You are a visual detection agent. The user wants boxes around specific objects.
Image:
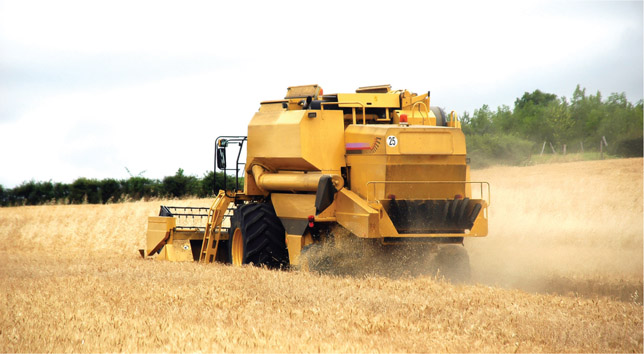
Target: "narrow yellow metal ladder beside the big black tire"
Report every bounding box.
[199,190,234,263]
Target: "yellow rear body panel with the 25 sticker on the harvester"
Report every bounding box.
[345,125,467,199]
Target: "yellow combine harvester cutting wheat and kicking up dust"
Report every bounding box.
[141,85,490,274]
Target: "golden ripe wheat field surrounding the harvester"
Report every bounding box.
[0,159,643,352]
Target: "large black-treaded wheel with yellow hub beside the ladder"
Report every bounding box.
[228,203,289,268]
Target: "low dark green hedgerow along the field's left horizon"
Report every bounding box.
[0,169,243,206]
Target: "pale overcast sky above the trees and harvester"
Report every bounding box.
[0,0,643,188]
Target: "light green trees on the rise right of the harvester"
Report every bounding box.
[461,85,644,167]
